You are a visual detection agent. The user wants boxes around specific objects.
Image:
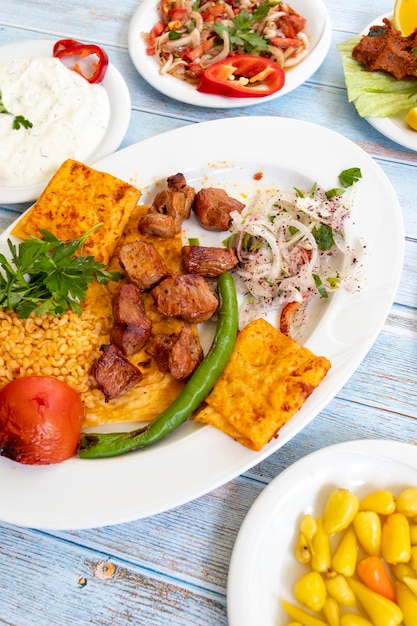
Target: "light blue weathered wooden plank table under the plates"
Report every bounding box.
[0,0,417,626]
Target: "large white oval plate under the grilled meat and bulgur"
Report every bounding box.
[0,116,404,529]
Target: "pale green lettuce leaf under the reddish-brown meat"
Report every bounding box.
[337,36,417,117]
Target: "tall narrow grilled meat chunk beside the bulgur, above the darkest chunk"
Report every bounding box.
[110,283,152,356]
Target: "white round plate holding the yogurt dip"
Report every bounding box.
[0,40,131,204]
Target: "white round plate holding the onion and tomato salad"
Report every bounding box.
[128,0,331,109]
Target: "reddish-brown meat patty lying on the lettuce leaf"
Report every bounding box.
[352,18,417,80]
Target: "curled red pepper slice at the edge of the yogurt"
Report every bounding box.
[53,39,109,83]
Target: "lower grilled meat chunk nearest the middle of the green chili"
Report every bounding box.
[147,323,204,380]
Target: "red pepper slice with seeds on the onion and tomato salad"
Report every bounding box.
[197,54,285,98]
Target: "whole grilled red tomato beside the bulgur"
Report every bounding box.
[0,376,84,465]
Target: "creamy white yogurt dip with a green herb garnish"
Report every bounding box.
[0,57,110,187]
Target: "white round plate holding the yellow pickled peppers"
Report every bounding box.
[227,440,417,626]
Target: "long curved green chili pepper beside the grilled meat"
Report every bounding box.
[78,273,238,459]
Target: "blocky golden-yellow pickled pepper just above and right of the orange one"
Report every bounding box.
[381,512,410,560]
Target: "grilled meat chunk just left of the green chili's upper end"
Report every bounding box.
[151,274,218,324]
